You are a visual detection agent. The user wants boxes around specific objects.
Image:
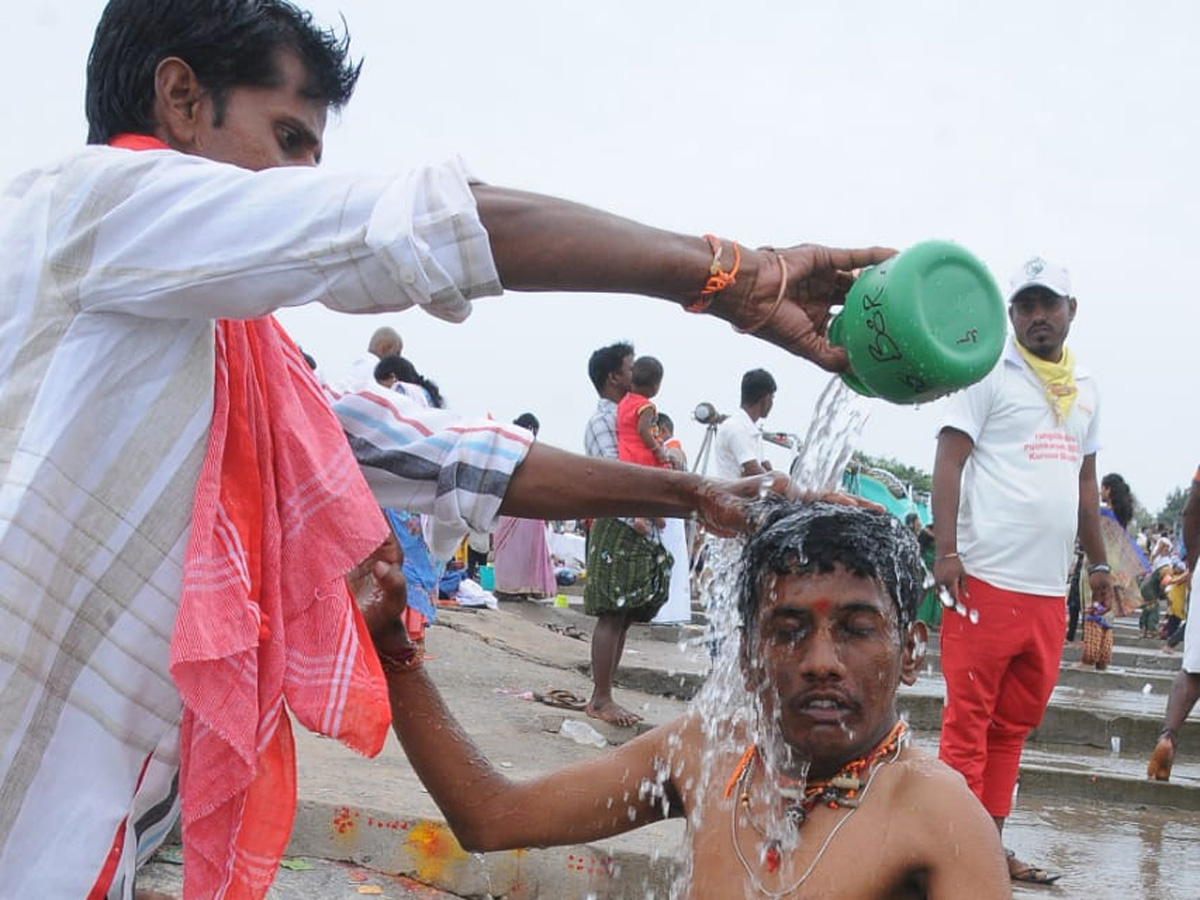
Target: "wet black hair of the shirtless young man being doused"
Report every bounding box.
[738,494,924,630]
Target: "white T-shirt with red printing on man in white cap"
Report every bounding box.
[942,338,1100,596]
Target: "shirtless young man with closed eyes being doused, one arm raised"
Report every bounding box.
[360,499,1012,900]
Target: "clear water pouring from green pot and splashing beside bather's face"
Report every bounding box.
[660,377,869,900]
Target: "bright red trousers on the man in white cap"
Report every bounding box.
[937,577,1067,817]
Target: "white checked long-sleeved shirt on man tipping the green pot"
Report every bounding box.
[0,146,500,896]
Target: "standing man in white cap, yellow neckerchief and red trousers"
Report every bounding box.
[932,257,1111,883]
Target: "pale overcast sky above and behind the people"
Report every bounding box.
[9,0,1200,511]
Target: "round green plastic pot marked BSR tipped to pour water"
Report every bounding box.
[829,241,1008,403]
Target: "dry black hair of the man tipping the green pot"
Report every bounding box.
[85,0,362,144]
